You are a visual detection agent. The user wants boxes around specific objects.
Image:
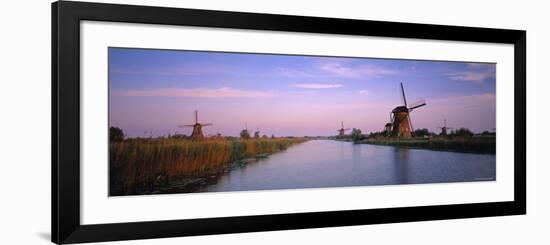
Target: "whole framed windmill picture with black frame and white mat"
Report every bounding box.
[52,1,526,244]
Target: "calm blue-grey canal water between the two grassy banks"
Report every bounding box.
[197,140,496,192]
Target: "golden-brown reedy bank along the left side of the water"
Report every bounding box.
[109,138,304,195]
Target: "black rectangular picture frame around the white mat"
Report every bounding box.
[51,1,526,244]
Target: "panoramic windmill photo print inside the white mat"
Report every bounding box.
[108,47,496,196]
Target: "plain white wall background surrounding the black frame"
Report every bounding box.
[0,0,550,245]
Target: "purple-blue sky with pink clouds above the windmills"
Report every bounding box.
[109,48,496,137]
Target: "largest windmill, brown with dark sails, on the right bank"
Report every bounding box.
[391,83,426,138]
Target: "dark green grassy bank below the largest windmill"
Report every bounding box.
[356,136,496,154]
